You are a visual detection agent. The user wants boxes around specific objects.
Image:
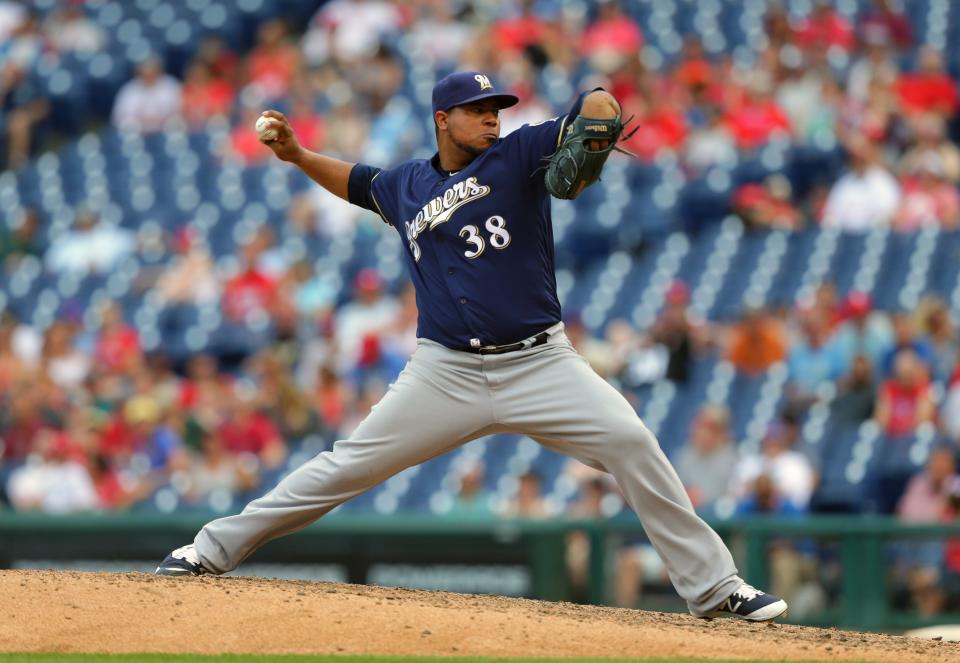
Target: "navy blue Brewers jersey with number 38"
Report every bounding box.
[349,95,584,350]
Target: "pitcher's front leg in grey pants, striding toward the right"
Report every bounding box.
[495,343,742,614]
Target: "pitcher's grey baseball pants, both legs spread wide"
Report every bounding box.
[194,325,742,615]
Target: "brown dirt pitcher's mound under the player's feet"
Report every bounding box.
[0,571,960,663]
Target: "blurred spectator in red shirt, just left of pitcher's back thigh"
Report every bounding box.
[217,384,287,469]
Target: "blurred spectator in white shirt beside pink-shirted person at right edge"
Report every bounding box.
[823,134,900,232]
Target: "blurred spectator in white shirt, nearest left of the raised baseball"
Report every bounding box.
[113,58,181,133]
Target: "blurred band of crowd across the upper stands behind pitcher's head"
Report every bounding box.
[0,0,960,231]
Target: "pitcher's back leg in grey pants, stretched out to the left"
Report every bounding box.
[194,350,491,573]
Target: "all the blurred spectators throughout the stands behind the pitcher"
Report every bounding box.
[0,0,960,611]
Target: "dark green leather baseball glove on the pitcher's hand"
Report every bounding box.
[544,116,633,200]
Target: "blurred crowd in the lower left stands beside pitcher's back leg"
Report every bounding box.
[0,258,416,512]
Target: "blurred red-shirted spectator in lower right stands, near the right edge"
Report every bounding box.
[874,349,936,437]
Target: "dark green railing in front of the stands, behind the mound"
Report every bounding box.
[0,512,960,631]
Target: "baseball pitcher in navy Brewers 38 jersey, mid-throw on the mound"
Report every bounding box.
[157,72,787,621]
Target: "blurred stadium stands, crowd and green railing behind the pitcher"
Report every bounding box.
[0,0,960,629]
